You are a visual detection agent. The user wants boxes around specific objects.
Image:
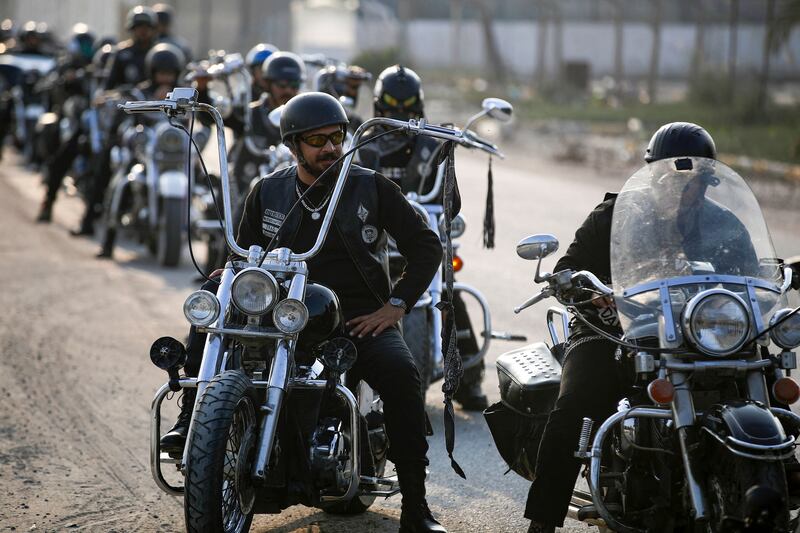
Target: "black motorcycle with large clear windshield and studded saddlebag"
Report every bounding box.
[486,158,800,532]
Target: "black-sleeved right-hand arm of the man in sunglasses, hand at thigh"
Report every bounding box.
[375,174,442,310]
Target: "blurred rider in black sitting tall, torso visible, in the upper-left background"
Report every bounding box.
[105,6,158,89]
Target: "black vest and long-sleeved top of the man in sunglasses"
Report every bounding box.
[236,165,442,310]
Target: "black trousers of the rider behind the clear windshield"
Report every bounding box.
[525,336,625,527]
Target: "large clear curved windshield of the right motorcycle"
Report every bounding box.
[611,158,785,345]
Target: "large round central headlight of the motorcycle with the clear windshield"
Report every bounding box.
[683,289,750,357]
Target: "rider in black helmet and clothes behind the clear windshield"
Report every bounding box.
[525,122,717,533]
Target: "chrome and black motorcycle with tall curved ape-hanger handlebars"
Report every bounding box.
[122,88,476,532]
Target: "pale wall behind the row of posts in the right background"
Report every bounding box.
[357,19,800,79]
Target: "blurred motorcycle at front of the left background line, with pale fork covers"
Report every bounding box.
[103,89,208,267]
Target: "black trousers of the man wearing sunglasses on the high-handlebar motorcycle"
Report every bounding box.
[184,282,428,469]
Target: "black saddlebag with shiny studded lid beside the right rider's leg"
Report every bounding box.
[483,343,561,480]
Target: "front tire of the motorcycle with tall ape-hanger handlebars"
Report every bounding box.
[184,370,258,533]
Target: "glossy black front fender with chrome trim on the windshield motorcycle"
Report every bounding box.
[700,401,794,460]
